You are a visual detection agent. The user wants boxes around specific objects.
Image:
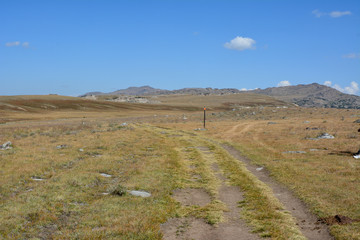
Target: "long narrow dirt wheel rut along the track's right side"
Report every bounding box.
[222,145,334,240]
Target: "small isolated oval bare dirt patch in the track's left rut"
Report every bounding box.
[173,188,211,207]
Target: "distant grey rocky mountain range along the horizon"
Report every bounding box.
[81,83,360,109]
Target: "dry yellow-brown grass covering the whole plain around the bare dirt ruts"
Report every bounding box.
[0,96,360,239]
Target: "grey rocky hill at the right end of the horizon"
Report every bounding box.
[250,83,360,109]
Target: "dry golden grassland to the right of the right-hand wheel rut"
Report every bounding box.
[161,107,360,239]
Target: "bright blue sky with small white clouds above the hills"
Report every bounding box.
[0,0,360,96]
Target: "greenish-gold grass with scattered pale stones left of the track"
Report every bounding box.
[0,125,186,239]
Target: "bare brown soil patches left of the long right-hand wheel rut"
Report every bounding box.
[161,147,260,240]
